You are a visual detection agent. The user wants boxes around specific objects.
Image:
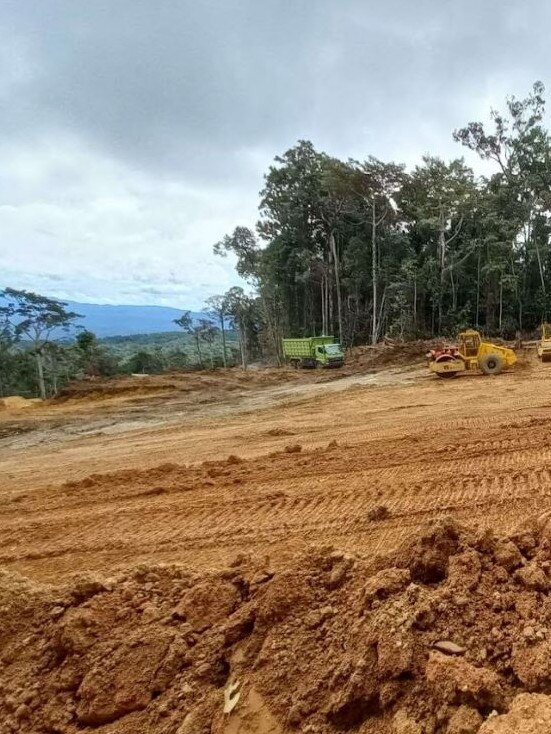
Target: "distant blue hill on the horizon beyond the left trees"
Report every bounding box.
[66,301,205,337]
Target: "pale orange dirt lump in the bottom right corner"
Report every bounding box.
[478,693,551,734]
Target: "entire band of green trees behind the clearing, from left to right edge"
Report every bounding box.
[0,82,551,397]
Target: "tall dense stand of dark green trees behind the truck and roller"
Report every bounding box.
[209,82,551,364]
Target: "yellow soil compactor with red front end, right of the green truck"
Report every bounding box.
[427,329,516,377]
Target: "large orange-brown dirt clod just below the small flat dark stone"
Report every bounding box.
[426,652,504,710]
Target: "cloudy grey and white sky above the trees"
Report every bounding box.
[0,0,551,309]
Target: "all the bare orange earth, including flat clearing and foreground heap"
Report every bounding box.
[5,344,551,734]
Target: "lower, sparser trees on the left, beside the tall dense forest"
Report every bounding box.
[0,288,241,399]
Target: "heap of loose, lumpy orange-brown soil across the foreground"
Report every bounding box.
[5,516,551,734]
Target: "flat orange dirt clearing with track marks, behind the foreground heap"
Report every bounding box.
[0,364,551,579]
